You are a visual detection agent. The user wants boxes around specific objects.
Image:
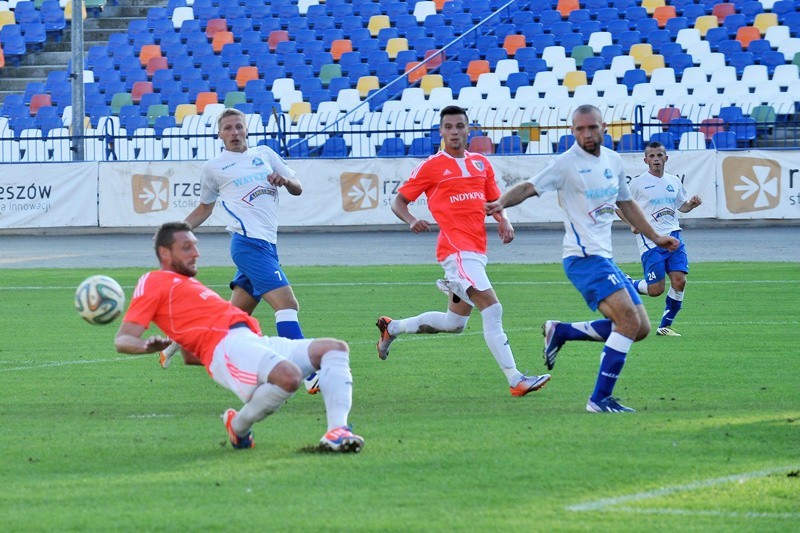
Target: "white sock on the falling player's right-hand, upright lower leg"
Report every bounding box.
[319,350,353,431]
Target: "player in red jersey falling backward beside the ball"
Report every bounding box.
[114,222,364,452]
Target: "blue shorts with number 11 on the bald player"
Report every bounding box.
[562,255,642,311]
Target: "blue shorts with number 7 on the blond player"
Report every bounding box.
[231,233,289,300]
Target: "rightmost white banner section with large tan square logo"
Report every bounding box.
[715,150,800,219]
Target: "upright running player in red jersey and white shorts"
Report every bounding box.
[377,106,550,396]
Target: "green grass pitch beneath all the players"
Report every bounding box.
[0,263,800,532]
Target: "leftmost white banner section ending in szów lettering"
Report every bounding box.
[0,162,97,229]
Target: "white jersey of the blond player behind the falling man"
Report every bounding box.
[200,146,294,244]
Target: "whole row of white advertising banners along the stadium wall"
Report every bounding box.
[0,150,800,229]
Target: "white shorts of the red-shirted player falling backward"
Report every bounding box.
[208,328,314,403]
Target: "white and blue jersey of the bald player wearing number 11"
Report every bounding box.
[528,143,630,258]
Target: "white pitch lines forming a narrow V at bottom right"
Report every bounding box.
[566,465,800,518]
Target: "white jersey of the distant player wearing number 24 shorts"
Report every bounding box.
[630,172,688,254]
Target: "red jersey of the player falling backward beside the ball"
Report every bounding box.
[123,270,261,368]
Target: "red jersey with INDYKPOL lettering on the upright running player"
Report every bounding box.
[399,151,500,261]
